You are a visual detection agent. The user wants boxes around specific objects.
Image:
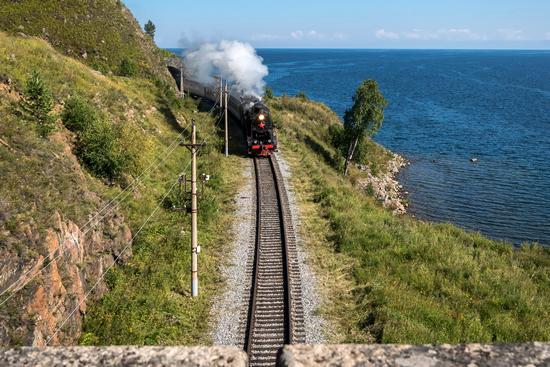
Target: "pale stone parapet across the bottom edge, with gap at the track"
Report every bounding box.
[0,343,550,367]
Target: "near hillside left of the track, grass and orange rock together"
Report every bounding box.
[0,25,244,345]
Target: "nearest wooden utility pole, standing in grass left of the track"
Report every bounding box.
[184,119,203,297]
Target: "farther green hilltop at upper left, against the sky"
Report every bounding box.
[0,0,168,79]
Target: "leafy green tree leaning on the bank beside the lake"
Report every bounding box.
[344,80,388,175]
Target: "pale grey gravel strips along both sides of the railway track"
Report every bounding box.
[211,154,326,346]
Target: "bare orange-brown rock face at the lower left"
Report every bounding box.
[0,212,132,346]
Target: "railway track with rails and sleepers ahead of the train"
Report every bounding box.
[244,156,305,366]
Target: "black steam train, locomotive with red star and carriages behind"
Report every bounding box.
[183,79,277,156]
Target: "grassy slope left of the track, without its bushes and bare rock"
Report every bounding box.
[0,32,244,345]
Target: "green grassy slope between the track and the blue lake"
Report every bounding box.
[270,97,550,343]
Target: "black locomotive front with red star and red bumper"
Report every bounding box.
[248,102,277,156]
